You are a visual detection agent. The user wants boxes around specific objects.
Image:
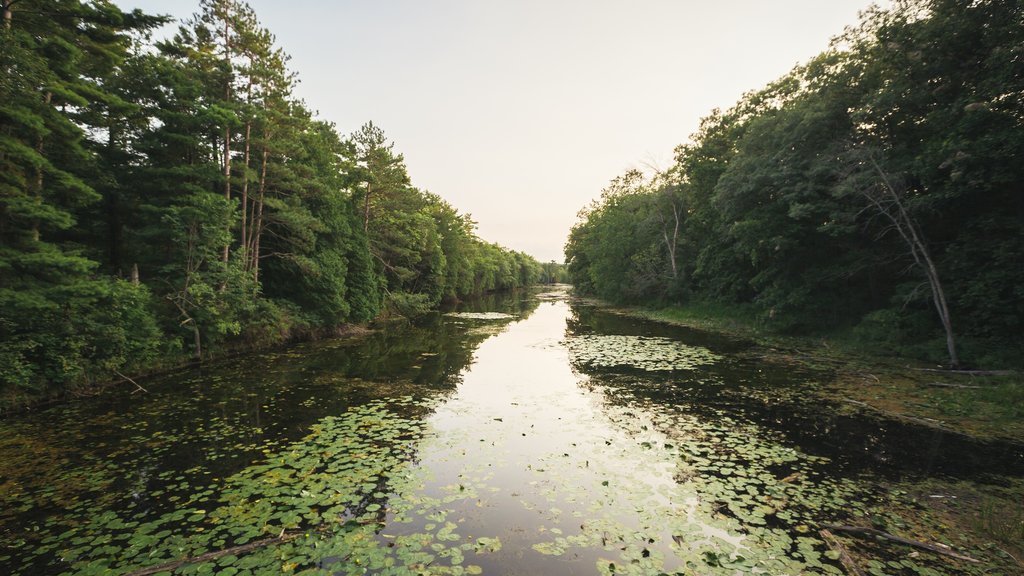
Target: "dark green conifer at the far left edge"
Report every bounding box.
[0,0,159,388]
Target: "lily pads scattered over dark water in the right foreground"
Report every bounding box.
[588,378,990,576]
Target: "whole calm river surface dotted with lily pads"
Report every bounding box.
[0,290,1024,575]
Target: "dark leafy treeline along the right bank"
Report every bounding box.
[565,0,1024,365]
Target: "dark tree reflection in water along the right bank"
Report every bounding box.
[566,305,1024,478]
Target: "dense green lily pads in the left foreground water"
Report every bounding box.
[2,398,501,574]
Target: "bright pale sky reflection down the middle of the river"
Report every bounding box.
[364,293,795,574]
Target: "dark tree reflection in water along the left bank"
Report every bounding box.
[0,294,538,574]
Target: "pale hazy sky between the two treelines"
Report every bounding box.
[110,0,870,261]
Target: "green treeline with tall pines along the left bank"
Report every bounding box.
[0,0,543,397]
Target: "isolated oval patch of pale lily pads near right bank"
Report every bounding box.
[564,334,722,372]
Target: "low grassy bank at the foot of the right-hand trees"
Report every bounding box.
[588,300,1024,443]
